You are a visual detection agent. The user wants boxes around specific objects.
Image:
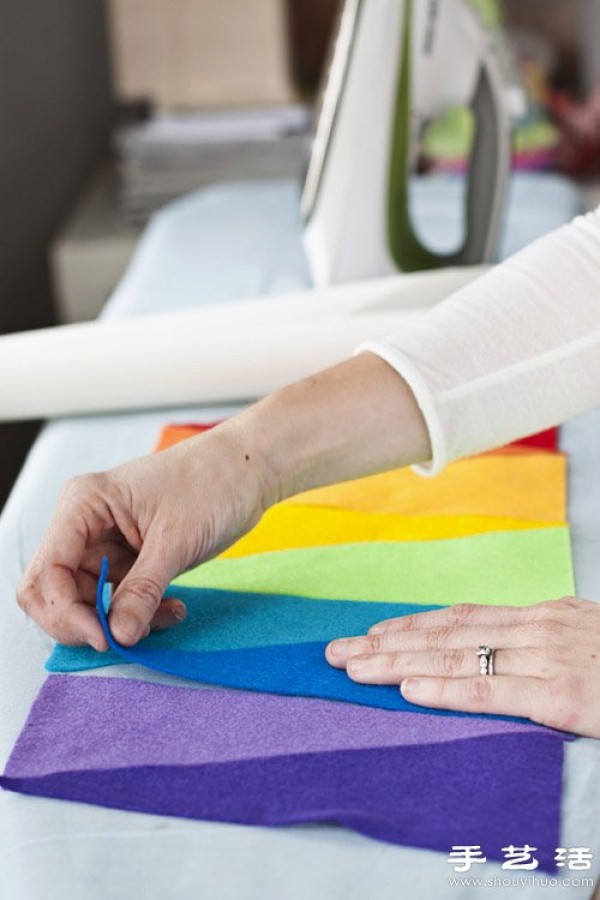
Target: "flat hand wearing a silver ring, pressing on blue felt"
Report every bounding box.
[327,597,600,738]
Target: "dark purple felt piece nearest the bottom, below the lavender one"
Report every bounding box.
[0,732,563,870]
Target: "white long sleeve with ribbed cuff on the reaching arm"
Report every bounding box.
[358,207,600,475]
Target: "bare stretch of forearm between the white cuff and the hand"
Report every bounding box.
[228,353,431,506]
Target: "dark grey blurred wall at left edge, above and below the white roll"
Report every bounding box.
[0,0,112,507]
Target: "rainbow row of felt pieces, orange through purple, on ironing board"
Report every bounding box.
[7,426,573,870]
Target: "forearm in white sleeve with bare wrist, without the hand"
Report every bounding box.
[203,212,600,506]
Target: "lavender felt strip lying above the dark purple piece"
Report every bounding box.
[0,675,563,777]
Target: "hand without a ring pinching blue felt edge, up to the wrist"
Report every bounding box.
[17,420,268,650]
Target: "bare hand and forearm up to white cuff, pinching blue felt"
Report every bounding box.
[17,353,431,650]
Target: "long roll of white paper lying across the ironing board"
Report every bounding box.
[0,267,484,421]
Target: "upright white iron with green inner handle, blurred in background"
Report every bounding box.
[302,0,511,286]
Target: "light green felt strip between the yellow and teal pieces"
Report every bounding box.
[175,526,575,606]
